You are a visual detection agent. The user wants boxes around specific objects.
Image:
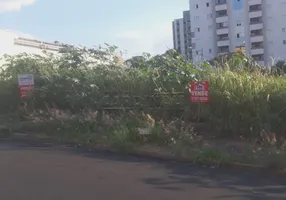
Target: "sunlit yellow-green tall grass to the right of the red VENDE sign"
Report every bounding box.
[208,70,286,138]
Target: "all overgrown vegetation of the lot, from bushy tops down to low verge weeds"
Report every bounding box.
[0,46,286,172]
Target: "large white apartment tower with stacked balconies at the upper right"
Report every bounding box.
[173,0,286,65]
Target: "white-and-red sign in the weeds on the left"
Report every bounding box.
[18,74,35,99]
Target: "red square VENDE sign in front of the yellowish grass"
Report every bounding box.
[191,81,209,103]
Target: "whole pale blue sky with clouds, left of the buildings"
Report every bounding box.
[0,0,188,56]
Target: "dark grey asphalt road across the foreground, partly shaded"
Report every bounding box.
[0,142,286,200]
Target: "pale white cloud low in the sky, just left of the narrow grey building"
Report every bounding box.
[115,23,173,57]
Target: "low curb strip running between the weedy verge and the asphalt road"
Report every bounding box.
[0,133,286,178]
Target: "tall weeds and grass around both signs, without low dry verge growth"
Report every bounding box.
[0,49,286,140]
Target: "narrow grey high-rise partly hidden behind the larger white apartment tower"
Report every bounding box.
[173,11,192,59]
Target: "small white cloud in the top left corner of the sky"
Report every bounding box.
[0,0,36,13]
